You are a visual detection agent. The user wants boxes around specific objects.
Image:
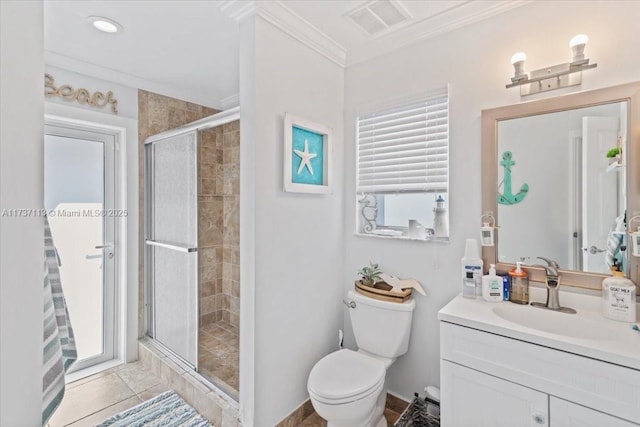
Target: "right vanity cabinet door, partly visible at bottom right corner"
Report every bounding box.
[549,396,639,427]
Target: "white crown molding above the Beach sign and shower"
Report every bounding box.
[44,50,222,110]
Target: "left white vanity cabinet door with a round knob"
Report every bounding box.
[440,360,549,427]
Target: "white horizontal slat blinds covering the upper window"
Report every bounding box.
[356,90,449,193]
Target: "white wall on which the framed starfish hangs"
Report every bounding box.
[240,18,344,427]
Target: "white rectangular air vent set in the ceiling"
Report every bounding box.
[346,0,411,36]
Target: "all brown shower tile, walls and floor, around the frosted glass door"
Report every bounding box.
[138,90,240,399]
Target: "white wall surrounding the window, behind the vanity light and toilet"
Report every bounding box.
[342,1,640,399]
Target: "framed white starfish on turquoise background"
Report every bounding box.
[284,113,331,194]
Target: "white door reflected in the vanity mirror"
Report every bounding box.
[582,117,619,273]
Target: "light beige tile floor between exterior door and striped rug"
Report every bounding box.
[49,362,169,427]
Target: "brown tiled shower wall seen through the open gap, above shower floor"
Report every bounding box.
[198,121,240,327]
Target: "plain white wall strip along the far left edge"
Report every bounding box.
[0,1,44,427]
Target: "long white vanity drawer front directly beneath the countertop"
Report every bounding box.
[440,322,640,423]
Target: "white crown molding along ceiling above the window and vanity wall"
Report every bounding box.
[346,0,533,66]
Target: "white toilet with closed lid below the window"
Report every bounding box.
[307,291,416,427]
